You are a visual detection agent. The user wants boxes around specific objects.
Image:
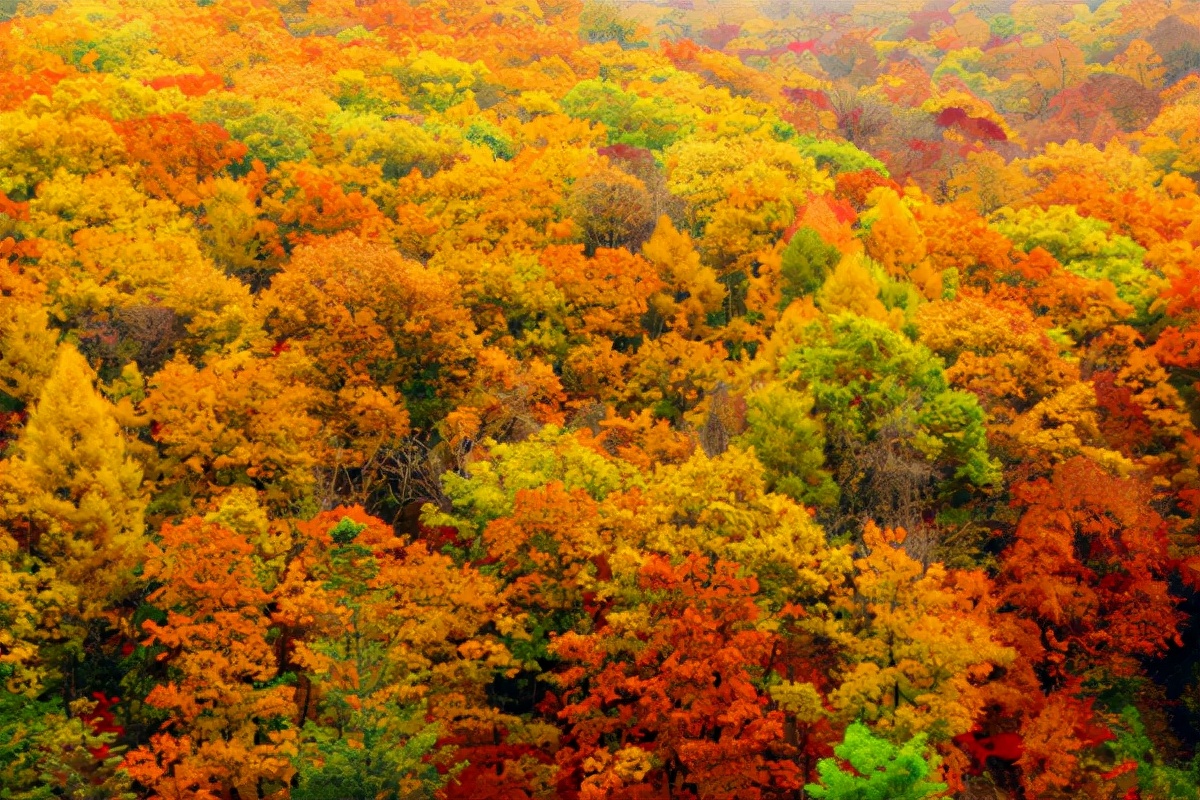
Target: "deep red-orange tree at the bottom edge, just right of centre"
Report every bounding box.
[552,555,803,798]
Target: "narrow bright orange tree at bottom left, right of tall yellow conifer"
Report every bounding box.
[124,517,296,800]
